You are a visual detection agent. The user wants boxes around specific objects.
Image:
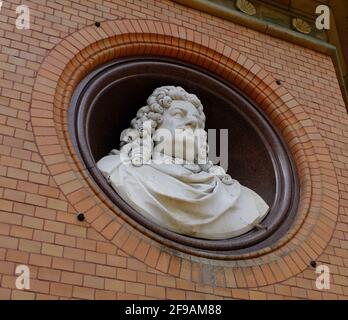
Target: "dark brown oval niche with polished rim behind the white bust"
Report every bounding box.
[69,57,299,256]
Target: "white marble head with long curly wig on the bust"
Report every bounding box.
[121,86,205,164]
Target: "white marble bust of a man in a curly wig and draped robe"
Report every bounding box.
[97,86,269,239]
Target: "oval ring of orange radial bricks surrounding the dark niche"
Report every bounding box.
[31,20,338,288]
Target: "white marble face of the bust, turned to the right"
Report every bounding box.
[153,100,205,161]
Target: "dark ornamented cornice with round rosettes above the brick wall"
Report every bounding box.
[173,0,348,110]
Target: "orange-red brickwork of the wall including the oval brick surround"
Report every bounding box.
[0,1,348,299]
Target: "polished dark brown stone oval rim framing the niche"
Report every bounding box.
[68,57,300,257]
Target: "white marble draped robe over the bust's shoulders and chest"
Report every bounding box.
[97,154,269,239]
